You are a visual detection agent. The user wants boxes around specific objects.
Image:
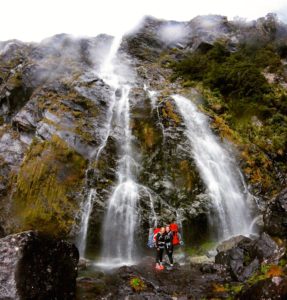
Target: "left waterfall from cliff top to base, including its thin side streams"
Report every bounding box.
[78,38,162,267]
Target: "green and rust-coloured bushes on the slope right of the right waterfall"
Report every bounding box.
[172,42,287,192]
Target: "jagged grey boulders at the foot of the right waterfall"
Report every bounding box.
[215,233,285,281]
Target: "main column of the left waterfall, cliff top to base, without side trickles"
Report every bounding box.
[95,38,144,266]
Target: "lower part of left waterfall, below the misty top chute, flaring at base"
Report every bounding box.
[102,84,139,265]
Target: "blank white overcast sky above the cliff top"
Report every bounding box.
[0,0,287,42]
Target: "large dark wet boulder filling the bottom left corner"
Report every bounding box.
[0,231,79,300]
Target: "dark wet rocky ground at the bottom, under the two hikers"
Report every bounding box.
[77,233,287,300]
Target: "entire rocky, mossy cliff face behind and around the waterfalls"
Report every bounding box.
[0,15,287,248]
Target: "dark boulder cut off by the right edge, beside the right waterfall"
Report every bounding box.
[264,189,287,238]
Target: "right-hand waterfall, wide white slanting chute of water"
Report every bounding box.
[173,95,251,240]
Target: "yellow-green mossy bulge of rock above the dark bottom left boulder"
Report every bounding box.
[13,136,86,236]
